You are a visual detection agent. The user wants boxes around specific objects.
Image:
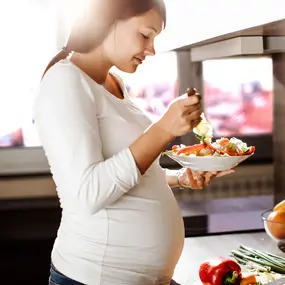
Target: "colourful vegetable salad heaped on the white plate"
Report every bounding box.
[168,113,255,156]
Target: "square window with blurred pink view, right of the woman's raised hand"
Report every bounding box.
[203,57,273,137]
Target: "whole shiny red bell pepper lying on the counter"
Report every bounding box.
[199,257,242,285]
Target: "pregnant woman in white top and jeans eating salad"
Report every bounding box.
[34,0,232,285]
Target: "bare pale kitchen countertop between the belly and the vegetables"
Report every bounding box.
[174,232,285,285]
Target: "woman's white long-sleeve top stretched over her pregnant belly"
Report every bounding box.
[34,60,184,285]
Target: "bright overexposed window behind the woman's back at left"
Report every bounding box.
[0,0,57,147]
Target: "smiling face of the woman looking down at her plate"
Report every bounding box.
[103,9,163,73]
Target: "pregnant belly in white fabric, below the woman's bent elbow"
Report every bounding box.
[57,165,184,285]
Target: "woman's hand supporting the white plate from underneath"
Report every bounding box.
[177,168,235,189]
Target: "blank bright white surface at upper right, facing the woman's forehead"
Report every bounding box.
[156,0,285,51]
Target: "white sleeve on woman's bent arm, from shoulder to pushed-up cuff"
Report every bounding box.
[34,64,141,215]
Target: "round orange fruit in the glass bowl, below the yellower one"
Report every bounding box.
[267,210,285,239]
